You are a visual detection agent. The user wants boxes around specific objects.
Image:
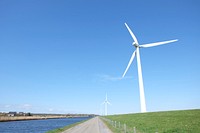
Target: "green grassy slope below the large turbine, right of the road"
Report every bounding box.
[105,109,200,133]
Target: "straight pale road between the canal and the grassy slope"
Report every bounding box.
[63,117,112,133]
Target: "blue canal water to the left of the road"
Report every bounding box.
[0,117,89,133]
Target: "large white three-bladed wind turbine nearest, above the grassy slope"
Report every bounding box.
[122,23,178,113]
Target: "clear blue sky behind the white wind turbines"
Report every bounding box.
[0,0,200,114]
